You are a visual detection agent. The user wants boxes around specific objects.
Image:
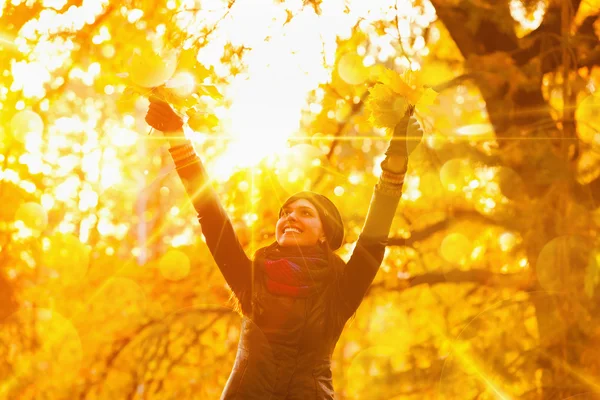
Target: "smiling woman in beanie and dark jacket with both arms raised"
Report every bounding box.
[146,99,422,400]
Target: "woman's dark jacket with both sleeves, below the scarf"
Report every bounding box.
[169,145,399,400]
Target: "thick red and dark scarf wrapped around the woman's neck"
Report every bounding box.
[255,243,334,298]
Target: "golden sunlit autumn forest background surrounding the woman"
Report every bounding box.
[0,0,600,400]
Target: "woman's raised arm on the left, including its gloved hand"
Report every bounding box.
[146,99,252,300]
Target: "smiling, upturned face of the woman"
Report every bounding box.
[275,199,325,247]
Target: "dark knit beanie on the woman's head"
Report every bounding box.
[279,191,344,250]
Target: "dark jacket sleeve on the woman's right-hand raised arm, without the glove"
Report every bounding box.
[338,173,404,315]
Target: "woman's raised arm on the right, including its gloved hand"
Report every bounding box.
[339,110,422,314]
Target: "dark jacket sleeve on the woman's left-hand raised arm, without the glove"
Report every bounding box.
[169,142,252,298]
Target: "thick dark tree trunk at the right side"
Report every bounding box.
[432,0,600,399]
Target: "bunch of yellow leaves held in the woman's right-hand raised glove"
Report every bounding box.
[366,68,437,129]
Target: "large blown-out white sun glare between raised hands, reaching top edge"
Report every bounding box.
[177,0,432,175]
